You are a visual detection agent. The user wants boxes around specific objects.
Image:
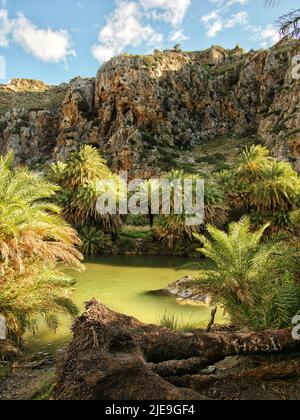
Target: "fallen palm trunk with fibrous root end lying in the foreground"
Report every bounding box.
[53,301,300,400]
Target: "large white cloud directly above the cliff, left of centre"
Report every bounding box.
[92,0,163,62]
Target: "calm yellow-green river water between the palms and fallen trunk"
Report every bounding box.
[26,256,221,353]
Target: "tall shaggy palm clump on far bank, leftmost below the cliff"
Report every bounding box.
[46,146,122,255]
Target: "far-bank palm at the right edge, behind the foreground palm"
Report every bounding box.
[218,146,300,230]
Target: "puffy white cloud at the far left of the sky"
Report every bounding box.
[0,9,76,63]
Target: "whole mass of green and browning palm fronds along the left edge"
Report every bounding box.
[0,153,83,344]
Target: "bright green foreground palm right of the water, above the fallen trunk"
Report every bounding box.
[195,217,300,328]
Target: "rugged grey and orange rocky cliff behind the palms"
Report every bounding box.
[0,40,300,174]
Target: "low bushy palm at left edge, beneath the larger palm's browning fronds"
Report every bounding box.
[0,259,78,346]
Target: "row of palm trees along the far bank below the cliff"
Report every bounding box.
[47,146,300,253]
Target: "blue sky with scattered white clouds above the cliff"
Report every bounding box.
[0,0,299,84]
